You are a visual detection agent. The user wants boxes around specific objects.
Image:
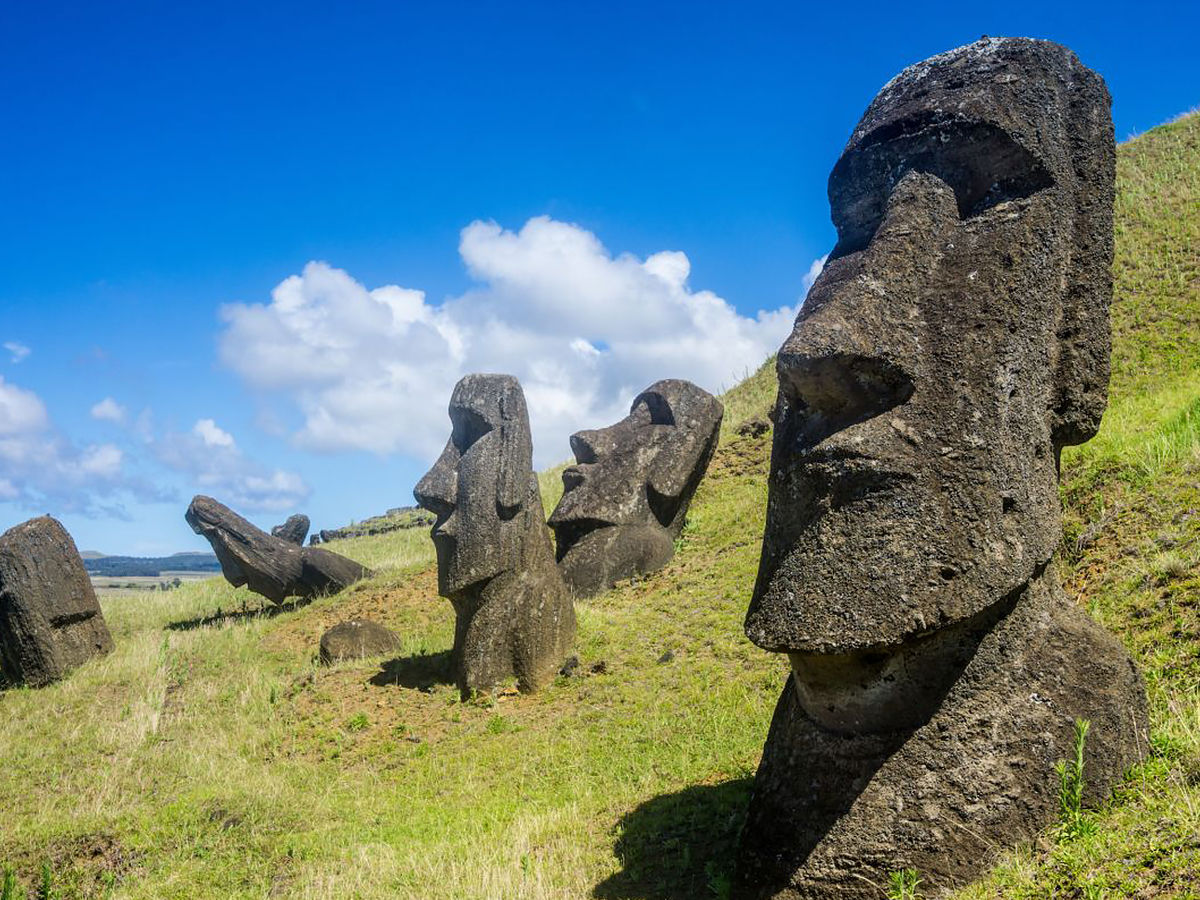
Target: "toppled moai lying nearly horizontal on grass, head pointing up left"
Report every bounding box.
[185,494,371,604]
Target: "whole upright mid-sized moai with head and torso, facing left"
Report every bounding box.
[413,374,575,696]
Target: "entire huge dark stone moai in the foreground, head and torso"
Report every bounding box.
[734,38,1147,898]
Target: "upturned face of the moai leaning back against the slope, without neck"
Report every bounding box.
[550,379,722,540]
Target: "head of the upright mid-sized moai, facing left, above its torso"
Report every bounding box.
[413,374,541,598]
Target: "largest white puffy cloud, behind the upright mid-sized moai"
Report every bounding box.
[220,216,796,464]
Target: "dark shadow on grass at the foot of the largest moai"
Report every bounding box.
[593,776,754,900]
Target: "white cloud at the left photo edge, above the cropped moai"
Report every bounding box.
[0,378,128,514]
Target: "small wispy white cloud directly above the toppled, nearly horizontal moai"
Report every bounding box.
[150,419,311,512]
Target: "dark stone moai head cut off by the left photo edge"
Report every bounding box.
[0,516,113,685]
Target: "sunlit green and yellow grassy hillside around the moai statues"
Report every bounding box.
[0,116,1200,900]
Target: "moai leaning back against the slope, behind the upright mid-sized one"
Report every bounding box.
[550,379,725,596]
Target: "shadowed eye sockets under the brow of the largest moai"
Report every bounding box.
[829,113,1054,258]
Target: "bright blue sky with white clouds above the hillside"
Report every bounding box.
[0,2,1200,554]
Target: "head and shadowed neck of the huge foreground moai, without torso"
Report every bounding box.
[745,38,1115,731]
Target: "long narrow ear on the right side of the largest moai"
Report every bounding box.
[1050,60,1116,449]
